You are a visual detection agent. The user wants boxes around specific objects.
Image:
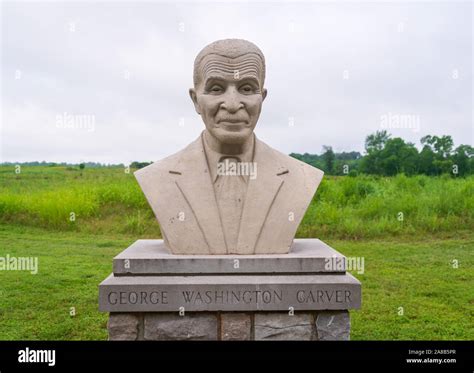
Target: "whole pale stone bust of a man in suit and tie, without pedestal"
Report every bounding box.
[135,39,323,254]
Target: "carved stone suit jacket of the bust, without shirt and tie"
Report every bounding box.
[135,135,324,254]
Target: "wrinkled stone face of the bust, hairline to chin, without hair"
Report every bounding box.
[189,54,267,144]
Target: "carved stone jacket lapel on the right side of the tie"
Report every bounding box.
[237,138,288,254]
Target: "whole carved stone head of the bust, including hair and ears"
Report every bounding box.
[189,39,267,151]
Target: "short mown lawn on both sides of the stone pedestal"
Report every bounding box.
[0,225,474,340]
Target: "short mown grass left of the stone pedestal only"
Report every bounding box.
[0,225,133,340]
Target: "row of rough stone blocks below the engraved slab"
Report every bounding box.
[107,310,350,341]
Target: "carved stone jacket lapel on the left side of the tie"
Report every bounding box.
[170,136,227,254]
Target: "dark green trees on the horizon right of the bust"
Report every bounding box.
[290,130,474,176]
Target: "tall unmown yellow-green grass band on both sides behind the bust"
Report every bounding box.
[0,166,474,239]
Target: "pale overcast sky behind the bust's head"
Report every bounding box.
[0,2,473,163]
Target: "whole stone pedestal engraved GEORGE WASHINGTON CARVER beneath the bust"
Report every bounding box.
[99,239,361,340]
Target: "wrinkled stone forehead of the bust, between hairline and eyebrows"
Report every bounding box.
[197,52,265,83]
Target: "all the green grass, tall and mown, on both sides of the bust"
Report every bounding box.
[0,166,474,340]
